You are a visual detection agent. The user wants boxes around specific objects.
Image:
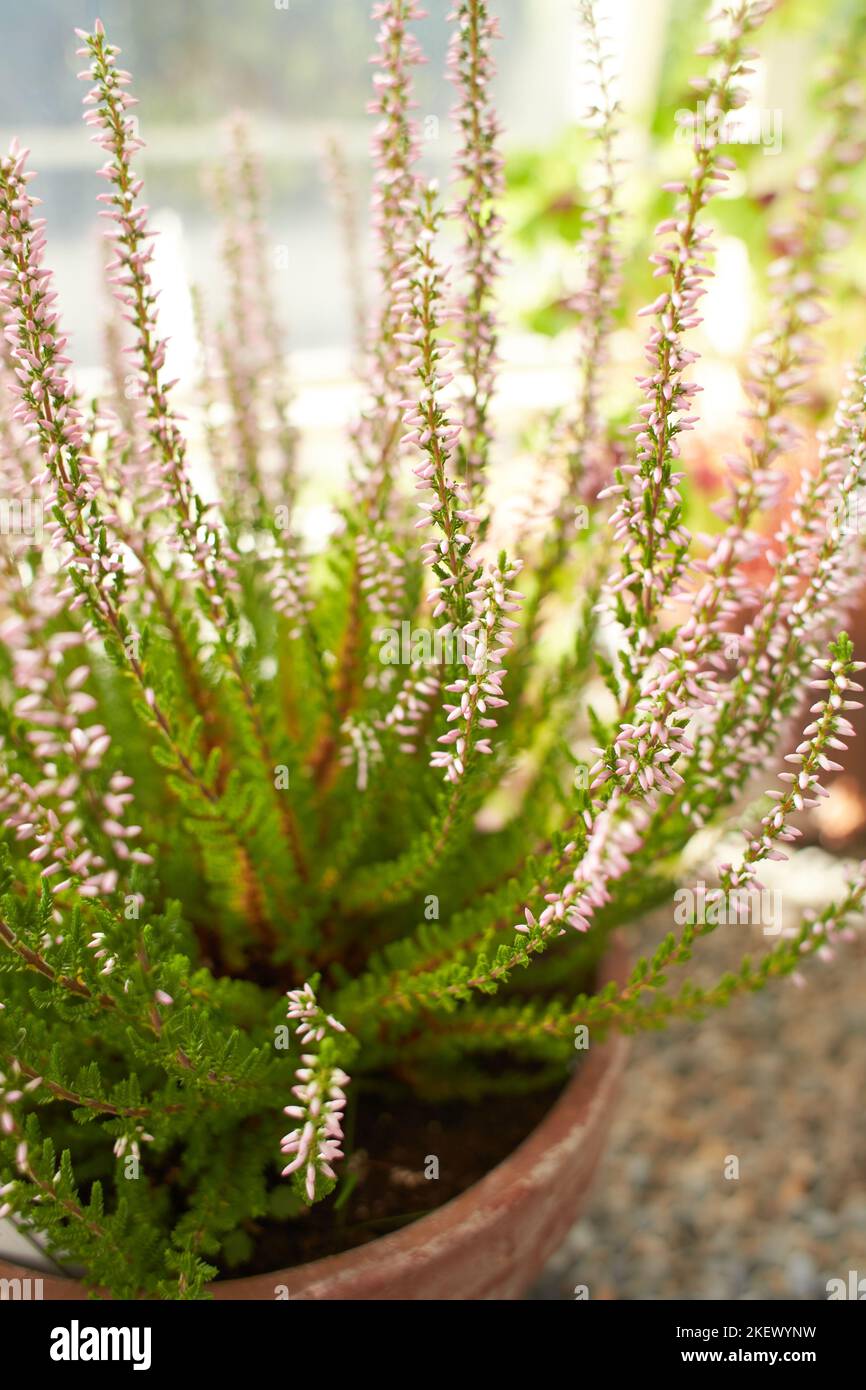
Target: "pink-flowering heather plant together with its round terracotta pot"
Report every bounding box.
[0,0,866,1298]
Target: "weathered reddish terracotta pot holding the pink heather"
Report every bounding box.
[0,945,628,1301]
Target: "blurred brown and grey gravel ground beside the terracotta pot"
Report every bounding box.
[528,851,866,1300]
